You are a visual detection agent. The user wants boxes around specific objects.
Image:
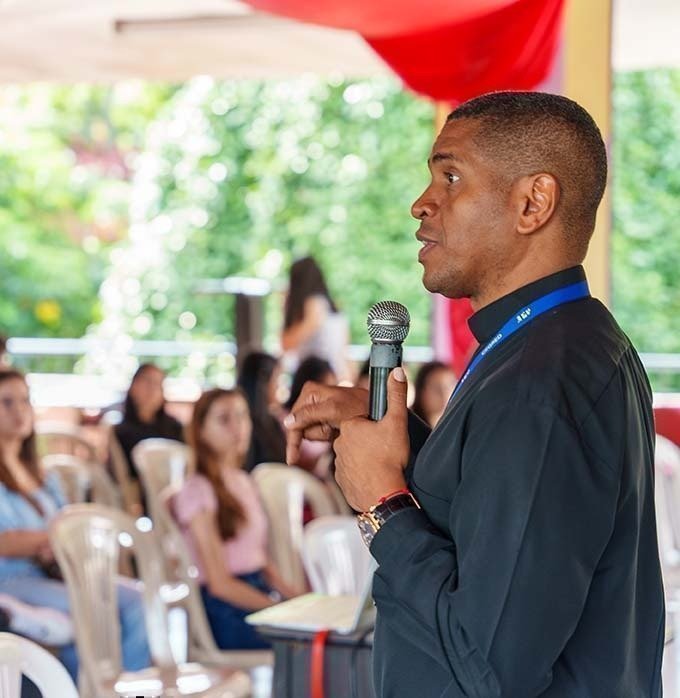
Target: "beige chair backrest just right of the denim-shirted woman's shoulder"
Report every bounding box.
[42,453,122,509]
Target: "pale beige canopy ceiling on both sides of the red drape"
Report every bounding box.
[0,0,680,83]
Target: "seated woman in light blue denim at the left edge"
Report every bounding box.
[0,370,151,679]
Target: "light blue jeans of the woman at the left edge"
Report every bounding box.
[0,577,151,681]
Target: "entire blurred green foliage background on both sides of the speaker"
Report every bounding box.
[0,70,680,386]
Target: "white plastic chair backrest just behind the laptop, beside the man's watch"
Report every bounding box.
[302,516,371,596]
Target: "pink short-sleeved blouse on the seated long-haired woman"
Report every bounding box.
[174,470,267,583]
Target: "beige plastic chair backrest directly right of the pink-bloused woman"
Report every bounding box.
[251,463,337,589]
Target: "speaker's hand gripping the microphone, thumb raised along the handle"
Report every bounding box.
[333,368,410,511]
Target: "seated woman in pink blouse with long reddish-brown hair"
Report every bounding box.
[174,388,295,650]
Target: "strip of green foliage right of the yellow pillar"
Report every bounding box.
[612,70,680,389]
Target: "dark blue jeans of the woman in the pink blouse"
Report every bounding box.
[201,572,271,650]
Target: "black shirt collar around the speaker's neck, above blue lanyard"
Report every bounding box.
[468,266,586,344]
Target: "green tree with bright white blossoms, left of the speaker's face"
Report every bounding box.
[98,77,433,380]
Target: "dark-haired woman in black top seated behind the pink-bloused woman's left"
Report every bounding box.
[114,364,184,480]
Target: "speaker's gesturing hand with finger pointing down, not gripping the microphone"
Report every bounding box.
[283,381,368,465]
